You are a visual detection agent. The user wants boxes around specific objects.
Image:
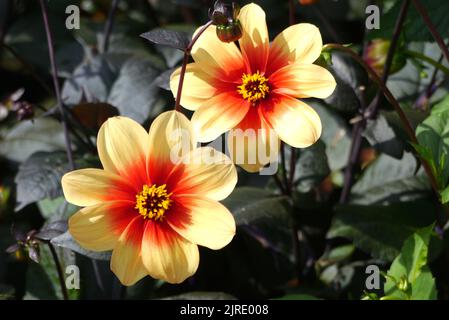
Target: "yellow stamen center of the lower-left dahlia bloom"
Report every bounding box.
[134,184,173,221]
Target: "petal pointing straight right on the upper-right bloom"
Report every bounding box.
[270,64,336,99]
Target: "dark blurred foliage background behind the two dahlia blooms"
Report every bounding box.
[0,0,449,299]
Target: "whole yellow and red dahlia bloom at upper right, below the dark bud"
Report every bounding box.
[170,4,336,171]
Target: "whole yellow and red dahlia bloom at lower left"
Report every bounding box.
[62,111,237,285]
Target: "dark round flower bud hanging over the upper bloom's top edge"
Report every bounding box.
[209,0,242,42]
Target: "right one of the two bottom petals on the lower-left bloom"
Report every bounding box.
[142,221,199,283]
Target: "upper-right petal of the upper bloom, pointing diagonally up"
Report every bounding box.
[267,23,323,75]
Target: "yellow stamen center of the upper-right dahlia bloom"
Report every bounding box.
[237,71,270,103]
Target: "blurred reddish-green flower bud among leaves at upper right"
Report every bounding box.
[363,39,406,77]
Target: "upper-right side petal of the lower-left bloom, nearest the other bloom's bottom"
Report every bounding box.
[169,147,237,200]
